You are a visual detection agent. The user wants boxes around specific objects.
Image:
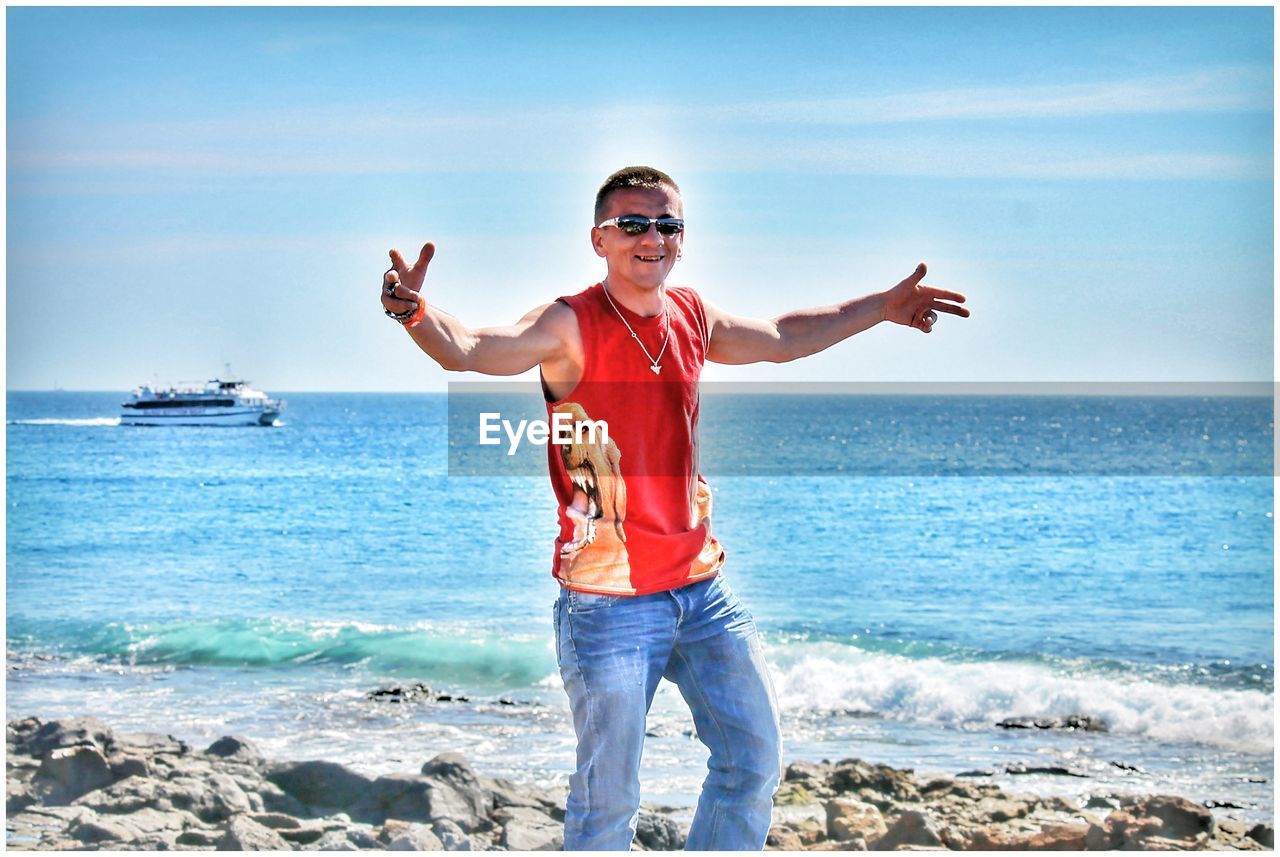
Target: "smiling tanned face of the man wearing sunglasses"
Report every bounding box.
[591,188,685,292]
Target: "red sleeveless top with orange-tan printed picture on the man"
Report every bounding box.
[547,283,724,595]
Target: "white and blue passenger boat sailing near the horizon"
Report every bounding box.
[120,379,284,426]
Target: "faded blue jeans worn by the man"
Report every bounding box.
[556,574,782,851]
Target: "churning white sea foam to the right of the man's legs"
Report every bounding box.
[769,643,1275,753]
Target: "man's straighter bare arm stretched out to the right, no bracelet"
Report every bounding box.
[705,262,969,363]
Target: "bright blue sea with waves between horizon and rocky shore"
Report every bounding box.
[5,386,1275,822]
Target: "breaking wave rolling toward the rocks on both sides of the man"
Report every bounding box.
[9,618,1275,752]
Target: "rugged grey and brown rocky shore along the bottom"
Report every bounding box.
[6,718,1272,851]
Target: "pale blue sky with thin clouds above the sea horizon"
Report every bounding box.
[6,6,1274,391]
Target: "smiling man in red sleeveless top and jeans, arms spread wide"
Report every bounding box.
[383,166,969,851]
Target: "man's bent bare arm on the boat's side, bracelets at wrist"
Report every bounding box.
[383,243,572,375]
